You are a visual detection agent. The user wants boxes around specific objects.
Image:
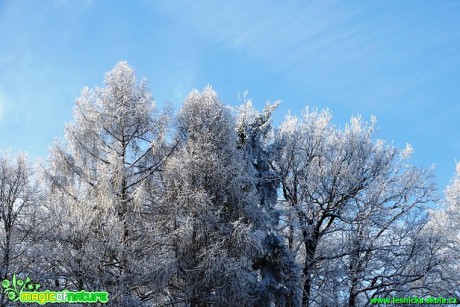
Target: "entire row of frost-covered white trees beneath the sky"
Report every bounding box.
[0,61,460,306]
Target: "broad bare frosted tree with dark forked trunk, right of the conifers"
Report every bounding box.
[275,109,434,306]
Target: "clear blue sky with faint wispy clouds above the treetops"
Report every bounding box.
[0,0,460,190]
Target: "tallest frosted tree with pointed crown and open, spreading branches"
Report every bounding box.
[43,62,172,306]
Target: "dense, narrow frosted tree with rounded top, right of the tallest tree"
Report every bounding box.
[165,87,262,306]
